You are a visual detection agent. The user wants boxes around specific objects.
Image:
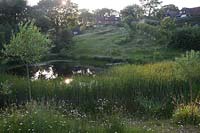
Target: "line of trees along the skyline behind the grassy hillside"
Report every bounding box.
[0,0,194,53]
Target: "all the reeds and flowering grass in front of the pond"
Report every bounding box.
[0,58,200,133]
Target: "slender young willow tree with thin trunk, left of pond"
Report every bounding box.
[3,22,51,100]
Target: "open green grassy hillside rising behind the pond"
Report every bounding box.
[65,26,181,63]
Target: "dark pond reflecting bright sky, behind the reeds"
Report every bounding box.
[6,61,104,82]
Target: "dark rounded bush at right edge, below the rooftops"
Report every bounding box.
[169,26,200,50]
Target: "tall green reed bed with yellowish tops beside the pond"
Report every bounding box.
[0,62,200,117]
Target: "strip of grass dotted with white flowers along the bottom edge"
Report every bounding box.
[0,102,199,133]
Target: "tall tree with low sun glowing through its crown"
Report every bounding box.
[31,0,78,53]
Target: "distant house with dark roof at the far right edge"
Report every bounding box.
[180,7,200,17]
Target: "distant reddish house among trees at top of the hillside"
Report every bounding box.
[96,15,121,25]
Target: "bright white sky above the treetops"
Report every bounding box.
[28,0,200,11]
